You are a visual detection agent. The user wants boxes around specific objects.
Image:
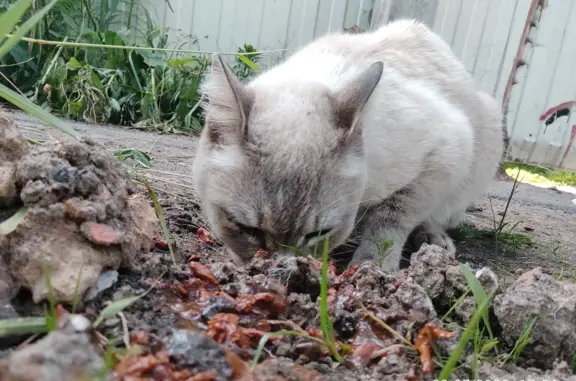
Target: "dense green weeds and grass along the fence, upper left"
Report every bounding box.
[0,0,261,133]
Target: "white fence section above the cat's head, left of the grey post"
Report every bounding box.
[140,0,381,51]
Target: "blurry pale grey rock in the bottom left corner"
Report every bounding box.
[0,330,111,381]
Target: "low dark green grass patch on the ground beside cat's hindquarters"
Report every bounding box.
[455,222,534,250]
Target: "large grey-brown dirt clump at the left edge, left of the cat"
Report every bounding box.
[0,117,158,302]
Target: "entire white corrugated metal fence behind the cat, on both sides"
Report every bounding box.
[145,0,576,171]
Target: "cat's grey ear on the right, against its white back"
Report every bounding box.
[336,61,384,130]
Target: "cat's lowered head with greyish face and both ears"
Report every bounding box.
[193,56,382,261]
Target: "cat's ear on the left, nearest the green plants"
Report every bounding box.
[204,54,254,143]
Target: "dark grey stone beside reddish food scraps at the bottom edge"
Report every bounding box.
[166,329,233,381]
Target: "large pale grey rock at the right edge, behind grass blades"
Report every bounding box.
[494,268,576,368]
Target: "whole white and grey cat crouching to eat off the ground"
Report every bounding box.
[194,20,503,270]
